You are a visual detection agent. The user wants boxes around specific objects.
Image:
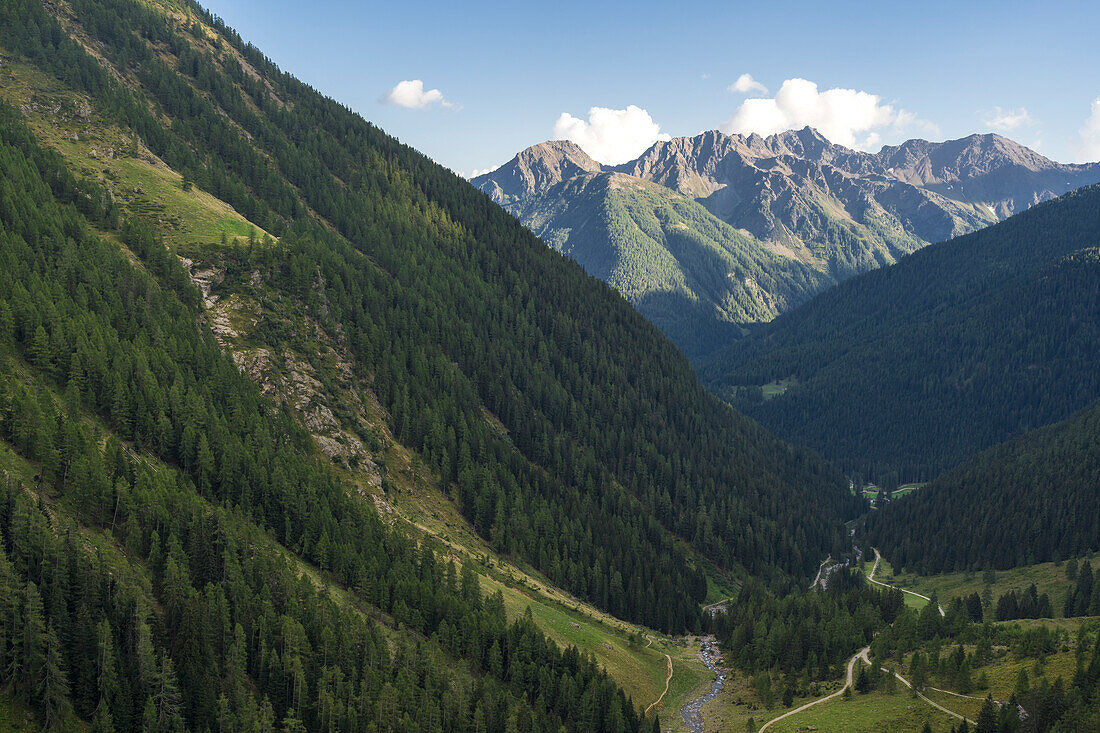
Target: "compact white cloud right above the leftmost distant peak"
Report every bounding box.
[552,105,672,165]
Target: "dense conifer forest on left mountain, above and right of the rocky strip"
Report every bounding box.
[0,0,857,631]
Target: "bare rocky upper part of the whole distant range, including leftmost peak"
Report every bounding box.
[473,127,1100,256]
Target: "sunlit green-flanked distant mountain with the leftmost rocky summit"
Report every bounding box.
[503,169,832,357]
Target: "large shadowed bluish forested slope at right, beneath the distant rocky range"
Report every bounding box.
[702,186,1100,479]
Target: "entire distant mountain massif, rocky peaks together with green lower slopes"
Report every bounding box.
[472,128,1100,359]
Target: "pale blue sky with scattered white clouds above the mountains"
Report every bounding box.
[206,0,1100,174]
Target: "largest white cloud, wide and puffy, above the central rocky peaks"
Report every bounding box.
[722,79,938,150]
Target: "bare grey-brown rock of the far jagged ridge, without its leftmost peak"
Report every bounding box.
[602,128,1100,245]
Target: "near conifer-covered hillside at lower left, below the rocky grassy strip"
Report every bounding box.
[0,101,640,731]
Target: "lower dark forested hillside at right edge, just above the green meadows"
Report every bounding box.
[867,391,1100,572]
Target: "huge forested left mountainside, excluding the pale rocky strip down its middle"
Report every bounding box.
[0,0,858,731]
